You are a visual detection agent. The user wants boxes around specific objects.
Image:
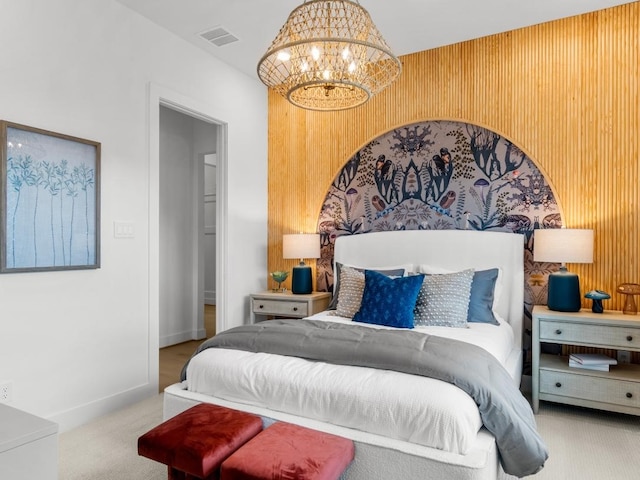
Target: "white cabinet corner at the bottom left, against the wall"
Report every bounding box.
[0,404,58,480]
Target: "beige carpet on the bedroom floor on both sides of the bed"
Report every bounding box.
[59,394,640,480]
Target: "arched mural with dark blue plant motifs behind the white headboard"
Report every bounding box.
[317,120,562,372]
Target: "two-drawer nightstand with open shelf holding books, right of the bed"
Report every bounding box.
[532,305,640,415]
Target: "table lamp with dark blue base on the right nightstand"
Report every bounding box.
[533,228,593,312]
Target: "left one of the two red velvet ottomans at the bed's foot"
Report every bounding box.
[138,403,262,480]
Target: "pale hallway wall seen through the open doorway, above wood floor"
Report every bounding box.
[159,106,219,348]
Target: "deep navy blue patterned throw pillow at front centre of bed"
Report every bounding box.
[353,270,424,328]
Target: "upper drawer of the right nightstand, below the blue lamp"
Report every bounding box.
[540,320,640,349]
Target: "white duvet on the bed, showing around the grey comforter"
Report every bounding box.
[186,313,513,454]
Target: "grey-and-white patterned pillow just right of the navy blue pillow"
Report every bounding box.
[413,269,474,327]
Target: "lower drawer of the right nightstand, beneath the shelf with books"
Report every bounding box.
[540,369,640,407]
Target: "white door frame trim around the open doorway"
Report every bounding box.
[148,82,228,389]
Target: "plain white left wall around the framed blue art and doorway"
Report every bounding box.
[0,0,267,430]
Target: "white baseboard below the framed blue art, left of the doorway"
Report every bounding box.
[48,380,158,433]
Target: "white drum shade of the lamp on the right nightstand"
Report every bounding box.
[533,228,593,263]
